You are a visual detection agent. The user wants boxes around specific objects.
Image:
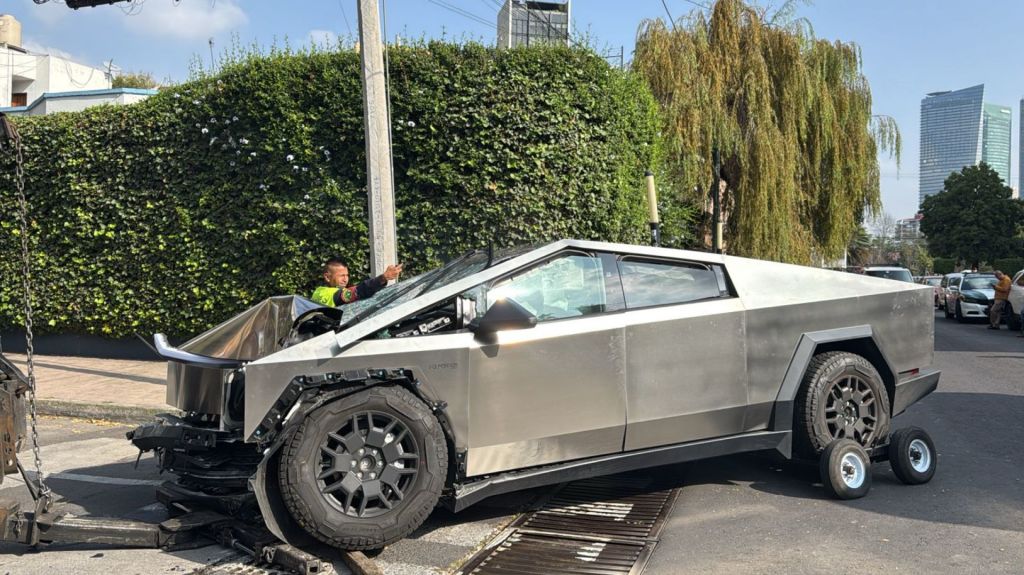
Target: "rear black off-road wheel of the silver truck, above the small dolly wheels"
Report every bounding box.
[794,351,890,458]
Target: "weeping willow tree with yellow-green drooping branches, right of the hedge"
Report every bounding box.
[633,0,900,263]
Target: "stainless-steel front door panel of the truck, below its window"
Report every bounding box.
[467,315,626,476]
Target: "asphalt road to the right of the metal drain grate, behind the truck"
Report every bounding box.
[646,314,1024,575]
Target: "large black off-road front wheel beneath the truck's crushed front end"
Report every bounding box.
[279,386,447,549]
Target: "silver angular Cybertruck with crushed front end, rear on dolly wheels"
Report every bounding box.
[129,240,939,548]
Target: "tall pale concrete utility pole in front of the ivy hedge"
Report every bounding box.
[358,0,398,276]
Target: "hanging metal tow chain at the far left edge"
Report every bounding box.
[0,114,53,512]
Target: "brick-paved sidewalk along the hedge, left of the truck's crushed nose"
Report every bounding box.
[4,353,174,423]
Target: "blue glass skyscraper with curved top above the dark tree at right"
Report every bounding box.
[918,84,1007,204]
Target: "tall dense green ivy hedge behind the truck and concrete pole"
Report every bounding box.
[0,43,659,337]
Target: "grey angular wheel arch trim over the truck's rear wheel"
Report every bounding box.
[769,325,896,437]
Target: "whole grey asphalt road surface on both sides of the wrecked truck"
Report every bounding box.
[0,314,1024,575]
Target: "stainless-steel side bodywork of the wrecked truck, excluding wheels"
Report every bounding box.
[157,240,934,479]
